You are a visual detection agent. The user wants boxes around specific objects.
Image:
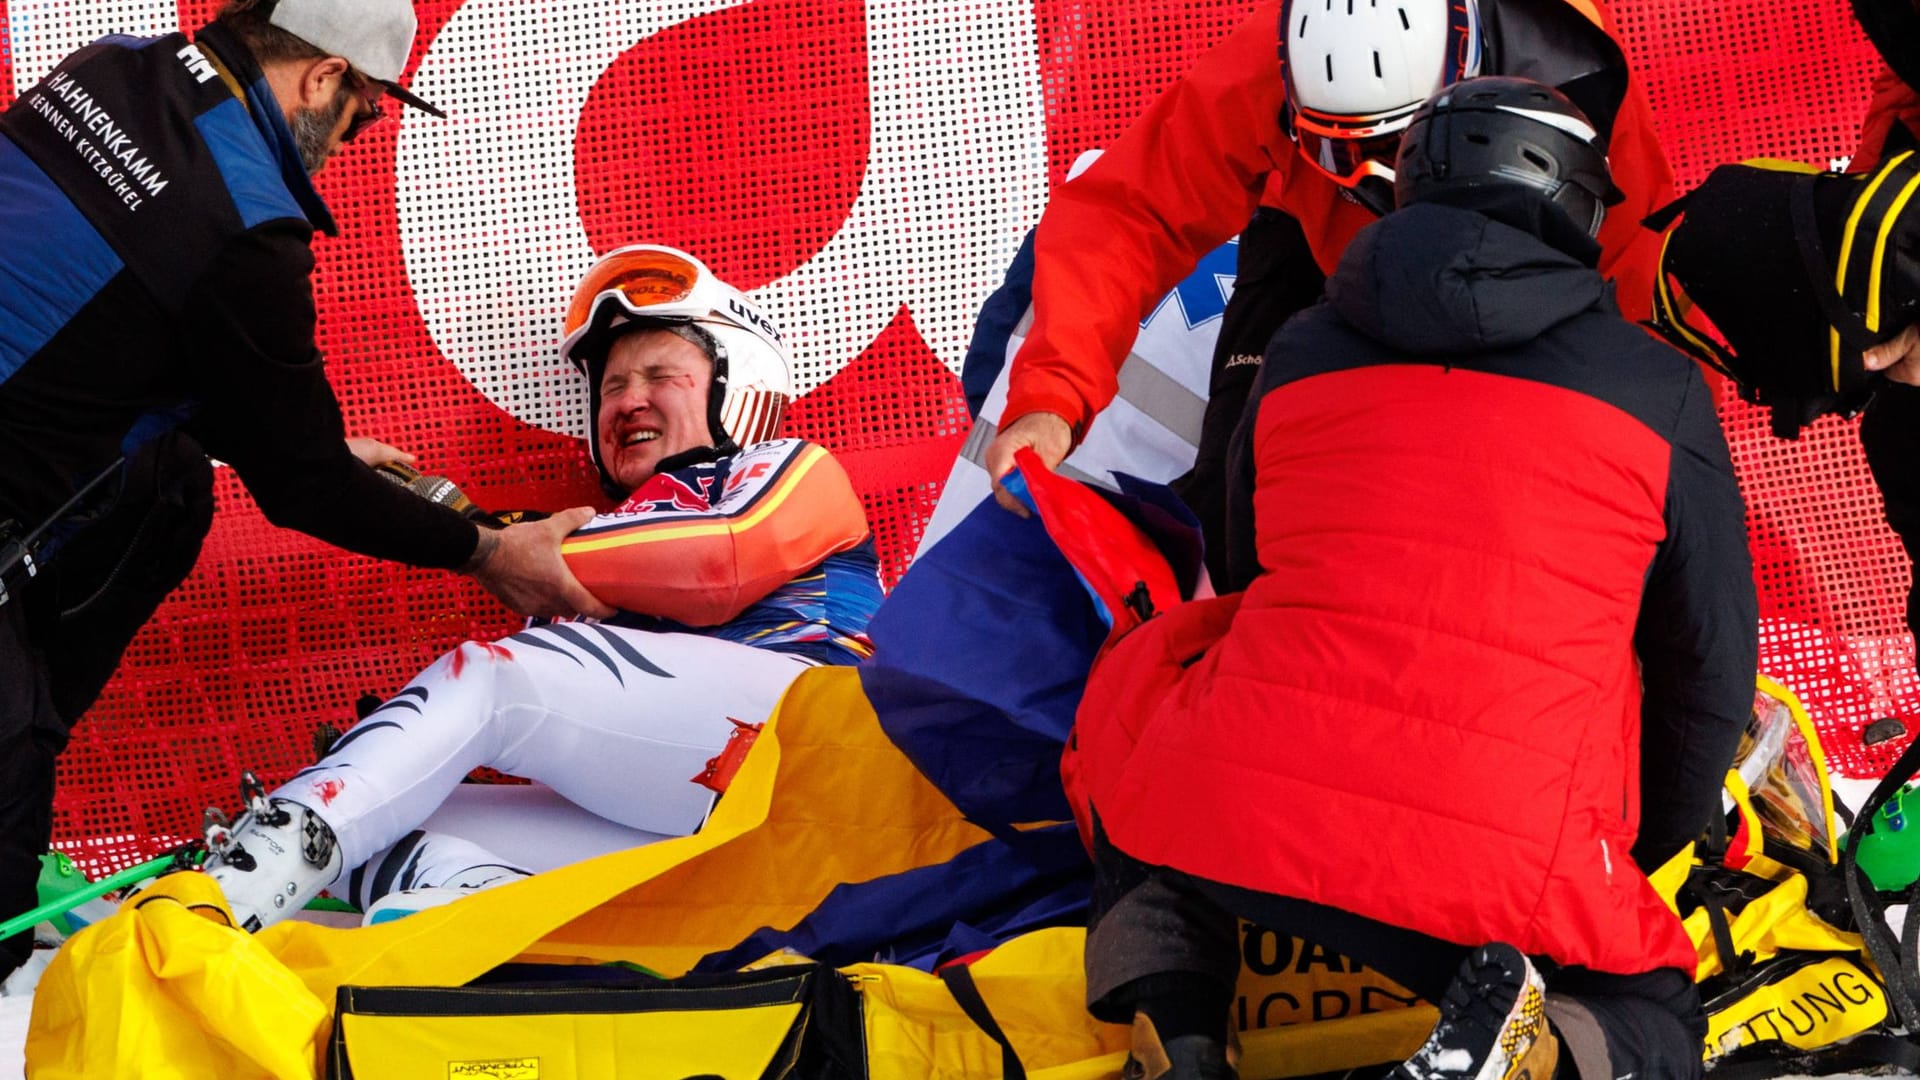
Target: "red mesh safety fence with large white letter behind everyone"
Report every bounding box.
[0,0,1920,872]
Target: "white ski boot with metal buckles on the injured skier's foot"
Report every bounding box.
[204,773,340,934]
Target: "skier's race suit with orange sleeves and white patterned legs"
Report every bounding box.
[273,440,881,905]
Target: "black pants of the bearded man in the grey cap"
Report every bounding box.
[0,434,213,978]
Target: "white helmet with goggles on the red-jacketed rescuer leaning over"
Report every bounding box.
[1281,0,1486,213]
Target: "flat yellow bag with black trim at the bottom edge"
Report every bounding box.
[326,965,866,1080]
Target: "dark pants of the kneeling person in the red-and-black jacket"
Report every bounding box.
[1087,826,1707,1080]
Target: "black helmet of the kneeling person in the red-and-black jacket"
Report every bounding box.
[1394,75,1622,236]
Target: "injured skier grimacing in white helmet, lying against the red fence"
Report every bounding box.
[194,246,881,930]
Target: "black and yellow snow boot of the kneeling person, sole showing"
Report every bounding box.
[1390,944,1559,1080]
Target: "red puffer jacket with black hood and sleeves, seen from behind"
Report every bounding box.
[1068,199,1757,972]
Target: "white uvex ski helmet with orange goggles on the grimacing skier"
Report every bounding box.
[561,244,793,479]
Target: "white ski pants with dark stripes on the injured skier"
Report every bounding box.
[275,623,810,903]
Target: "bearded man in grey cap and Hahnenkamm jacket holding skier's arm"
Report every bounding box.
[0,0,612,976]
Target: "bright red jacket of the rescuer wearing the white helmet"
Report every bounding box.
[1000,0,1672,430]
